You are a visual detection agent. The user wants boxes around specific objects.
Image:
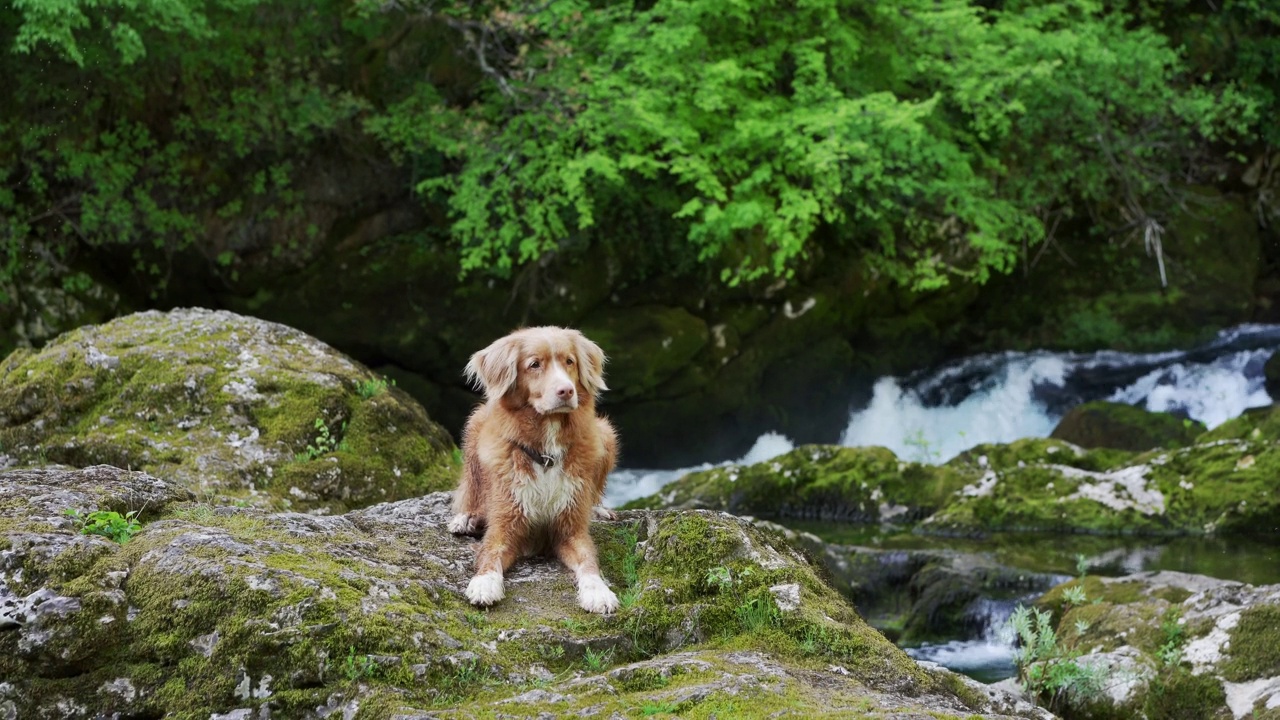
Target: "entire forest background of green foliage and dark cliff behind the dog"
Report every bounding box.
[0,0,1280,464]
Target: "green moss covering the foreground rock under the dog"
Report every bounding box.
[0,481,1018,717]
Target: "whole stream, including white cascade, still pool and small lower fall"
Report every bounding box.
[604,324,1280,682]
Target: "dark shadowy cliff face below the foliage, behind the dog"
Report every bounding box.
[0,154,1271,466]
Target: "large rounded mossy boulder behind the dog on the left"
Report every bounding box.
[0,309,457,512]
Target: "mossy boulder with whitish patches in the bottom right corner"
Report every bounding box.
[1024,571,1280,720]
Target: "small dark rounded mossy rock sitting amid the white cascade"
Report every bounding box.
[1050,400,1206,452]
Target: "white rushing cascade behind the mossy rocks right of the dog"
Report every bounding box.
[605,324,1280,506]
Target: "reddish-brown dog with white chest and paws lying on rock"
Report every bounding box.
[448,327,618,614]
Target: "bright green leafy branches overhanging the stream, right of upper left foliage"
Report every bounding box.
[369,0,1256,287]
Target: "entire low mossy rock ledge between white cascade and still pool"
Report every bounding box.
[628,427,1280,536]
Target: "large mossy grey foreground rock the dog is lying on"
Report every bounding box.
[0,468,1042,719]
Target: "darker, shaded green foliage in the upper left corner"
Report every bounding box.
[0,0,378,292]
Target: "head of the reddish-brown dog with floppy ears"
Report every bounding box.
[466,327,608,415]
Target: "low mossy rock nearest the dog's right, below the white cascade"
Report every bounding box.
[628,445,972,523]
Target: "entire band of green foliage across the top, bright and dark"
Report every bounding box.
[0,0,1280,294]
